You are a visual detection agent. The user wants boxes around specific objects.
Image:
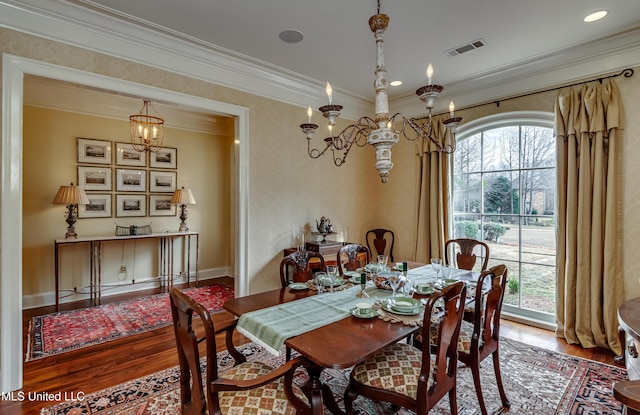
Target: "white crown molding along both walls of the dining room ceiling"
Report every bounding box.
[0,0,640,120]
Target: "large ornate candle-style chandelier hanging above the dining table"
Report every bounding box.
[300,0,462,183]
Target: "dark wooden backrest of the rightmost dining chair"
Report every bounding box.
[471,264,507,360]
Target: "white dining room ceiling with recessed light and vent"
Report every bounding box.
[71,0,640,100]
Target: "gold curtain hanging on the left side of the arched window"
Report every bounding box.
[414,118,450,264]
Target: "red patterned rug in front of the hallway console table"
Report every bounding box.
[26,284,234,362]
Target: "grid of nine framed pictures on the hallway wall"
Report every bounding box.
[76,137,178,218]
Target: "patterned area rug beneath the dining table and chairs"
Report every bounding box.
[41,339,626,415]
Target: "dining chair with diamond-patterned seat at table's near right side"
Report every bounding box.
[344,282,466,415]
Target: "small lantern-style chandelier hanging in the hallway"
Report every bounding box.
[129,100,164,153]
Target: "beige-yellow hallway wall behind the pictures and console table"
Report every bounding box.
[23,106,233,301]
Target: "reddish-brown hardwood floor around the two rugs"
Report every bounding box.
[0,278,615,415]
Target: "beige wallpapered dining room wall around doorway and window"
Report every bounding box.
[0,29,640,298]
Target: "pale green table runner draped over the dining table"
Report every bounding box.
[237,285,391,356]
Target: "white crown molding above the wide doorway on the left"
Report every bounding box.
[0,0,371,119]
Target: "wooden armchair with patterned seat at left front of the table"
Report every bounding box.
[169,287,310,415]
